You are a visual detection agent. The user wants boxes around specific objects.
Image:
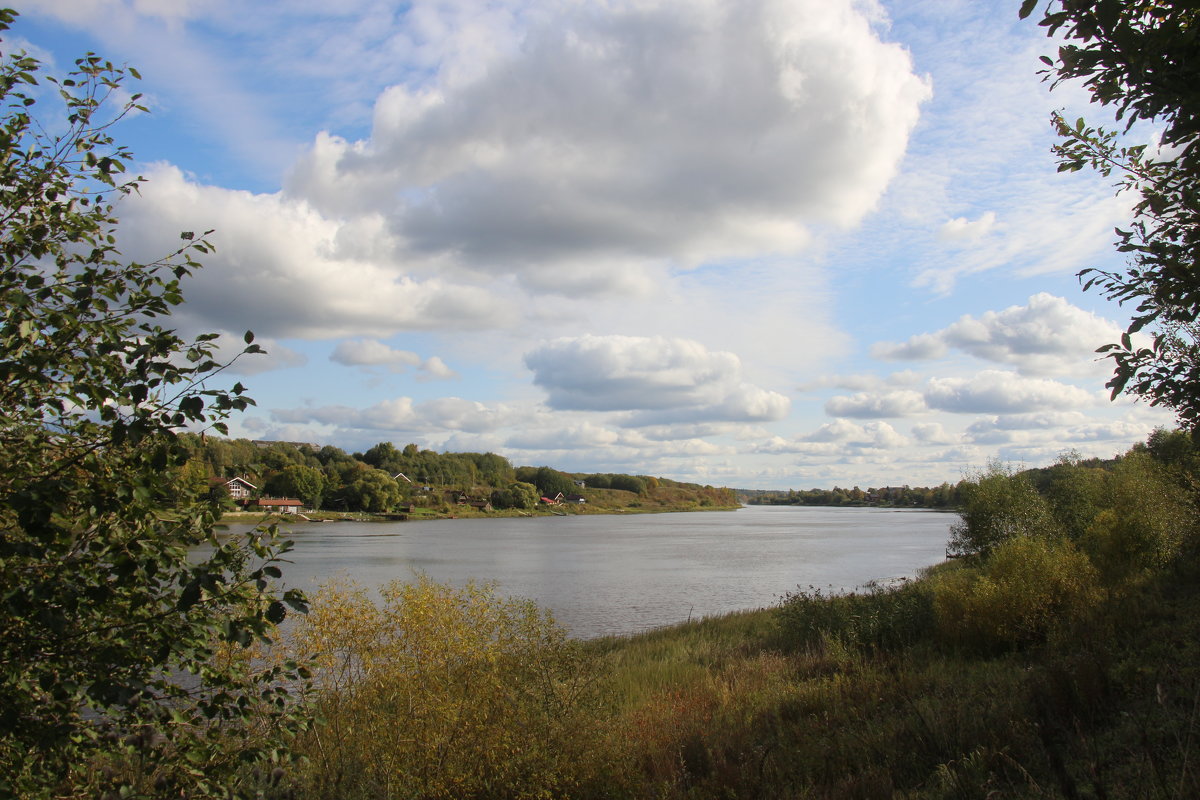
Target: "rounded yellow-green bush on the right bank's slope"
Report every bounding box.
[934,536,1100,651]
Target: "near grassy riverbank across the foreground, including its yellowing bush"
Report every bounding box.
[278,551,1200,800]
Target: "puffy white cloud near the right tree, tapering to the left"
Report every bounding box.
[871,291,1121,375]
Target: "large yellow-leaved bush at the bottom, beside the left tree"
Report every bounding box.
[295,577,611,799]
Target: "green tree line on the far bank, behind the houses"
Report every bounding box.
[171,434,737,513]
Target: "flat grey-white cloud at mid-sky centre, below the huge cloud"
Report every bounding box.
[524,336,790,425]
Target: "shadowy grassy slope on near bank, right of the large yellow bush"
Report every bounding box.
[568,556,1200,799]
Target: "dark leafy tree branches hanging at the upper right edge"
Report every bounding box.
[1020,0,1200,431]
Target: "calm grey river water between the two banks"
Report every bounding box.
[233,506,958,638]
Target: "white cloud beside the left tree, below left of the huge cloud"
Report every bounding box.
[112,166,508,338]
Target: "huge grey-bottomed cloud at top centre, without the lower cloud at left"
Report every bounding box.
[288,0,929,284]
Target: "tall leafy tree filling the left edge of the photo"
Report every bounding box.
[0,17,305,798]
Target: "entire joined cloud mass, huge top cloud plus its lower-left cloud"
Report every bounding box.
[108,0,930,338]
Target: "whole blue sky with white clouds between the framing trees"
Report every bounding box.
[2,0,1172,489]
